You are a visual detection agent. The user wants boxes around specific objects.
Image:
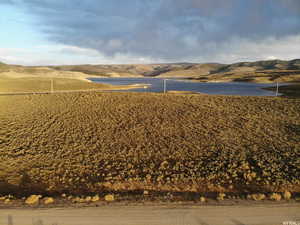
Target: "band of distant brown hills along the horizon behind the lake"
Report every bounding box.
[0,59,300,83]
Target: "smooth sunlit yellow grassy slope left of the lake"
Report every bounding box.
[0,64,115,93]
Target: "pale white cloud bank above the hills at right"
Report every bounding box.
[189,35,300,63]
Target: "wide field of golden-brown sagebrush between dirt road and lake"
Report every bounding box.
[0,93,300,195]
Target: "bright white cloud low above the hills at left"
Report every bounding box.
[0,45,159,66]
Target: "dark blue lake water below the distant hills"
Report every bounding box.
[89,78,275,96]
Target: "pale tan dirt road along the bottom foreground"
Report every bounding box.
[0,204,300,225]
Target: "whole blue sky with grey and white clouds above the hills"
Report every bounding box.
[0,0,300,65]
